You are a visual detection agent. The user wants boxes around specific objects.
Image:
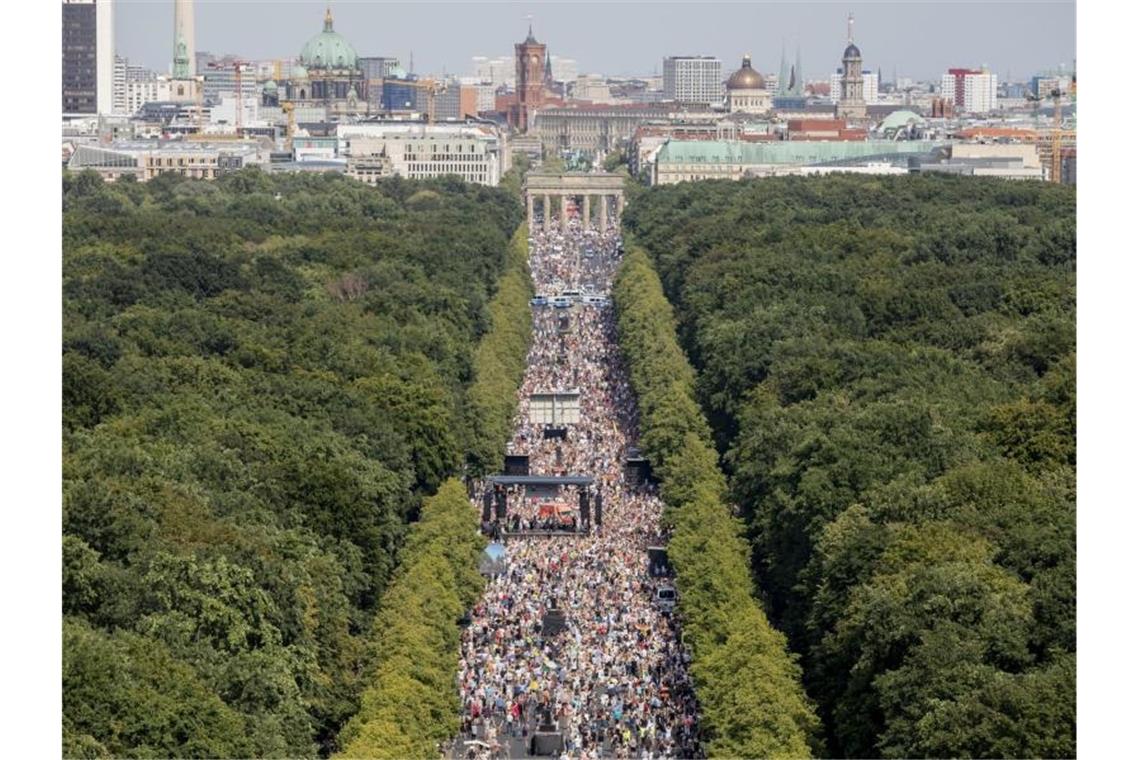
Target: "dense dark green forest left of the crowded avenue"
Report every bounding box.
[63,170,524,757]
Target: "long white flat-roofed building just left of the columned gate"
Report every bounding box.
[336,123,506,187]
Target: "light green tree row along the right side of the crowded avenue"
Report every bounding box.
[613,246,819,758]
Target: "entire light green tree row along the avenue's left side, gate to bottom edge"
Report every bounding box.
[340,219,532,758]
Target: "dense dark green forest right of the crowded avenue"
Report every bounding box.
[625,177,1076,758]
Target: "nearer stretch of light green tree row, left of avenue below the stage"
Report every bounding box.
[340,480,486,759]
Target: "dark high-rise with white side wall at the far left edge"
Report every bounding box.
[63,0,115,114]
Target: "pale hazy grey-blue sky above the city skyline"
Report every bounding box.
[115,0,1076,80]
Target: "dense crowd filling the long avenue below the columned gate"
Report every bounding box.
[457,222,700,759]
